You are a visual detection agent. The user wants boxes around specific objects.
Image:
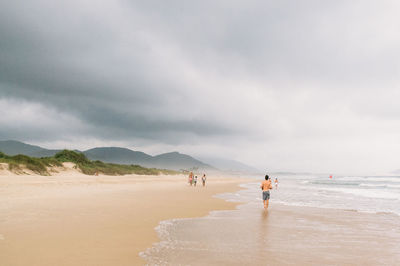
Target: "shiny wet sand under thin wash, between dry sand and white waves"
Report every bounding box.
[145,182,400,265]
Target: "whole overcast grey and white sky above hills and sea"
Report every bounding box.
[0,0,400,174]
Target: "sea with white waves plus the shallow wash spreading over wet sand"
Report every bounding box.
[141,175,400,265]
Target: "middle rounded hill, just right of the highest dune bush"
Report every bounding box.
[83,147,153,165]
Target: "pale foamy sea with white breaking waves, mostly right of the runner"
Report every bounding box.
[252,175,400,215]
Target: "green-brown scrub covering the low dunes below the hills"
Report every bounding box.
[0,150,178,175]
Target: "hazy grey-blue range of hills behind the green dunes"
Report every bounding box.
[0,140,217,170]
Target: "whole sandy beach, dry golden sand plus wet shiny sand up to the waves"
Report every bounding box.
[0,168,400,265]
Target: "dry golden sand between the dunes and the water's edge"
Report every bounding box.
[0,169,245,265]
